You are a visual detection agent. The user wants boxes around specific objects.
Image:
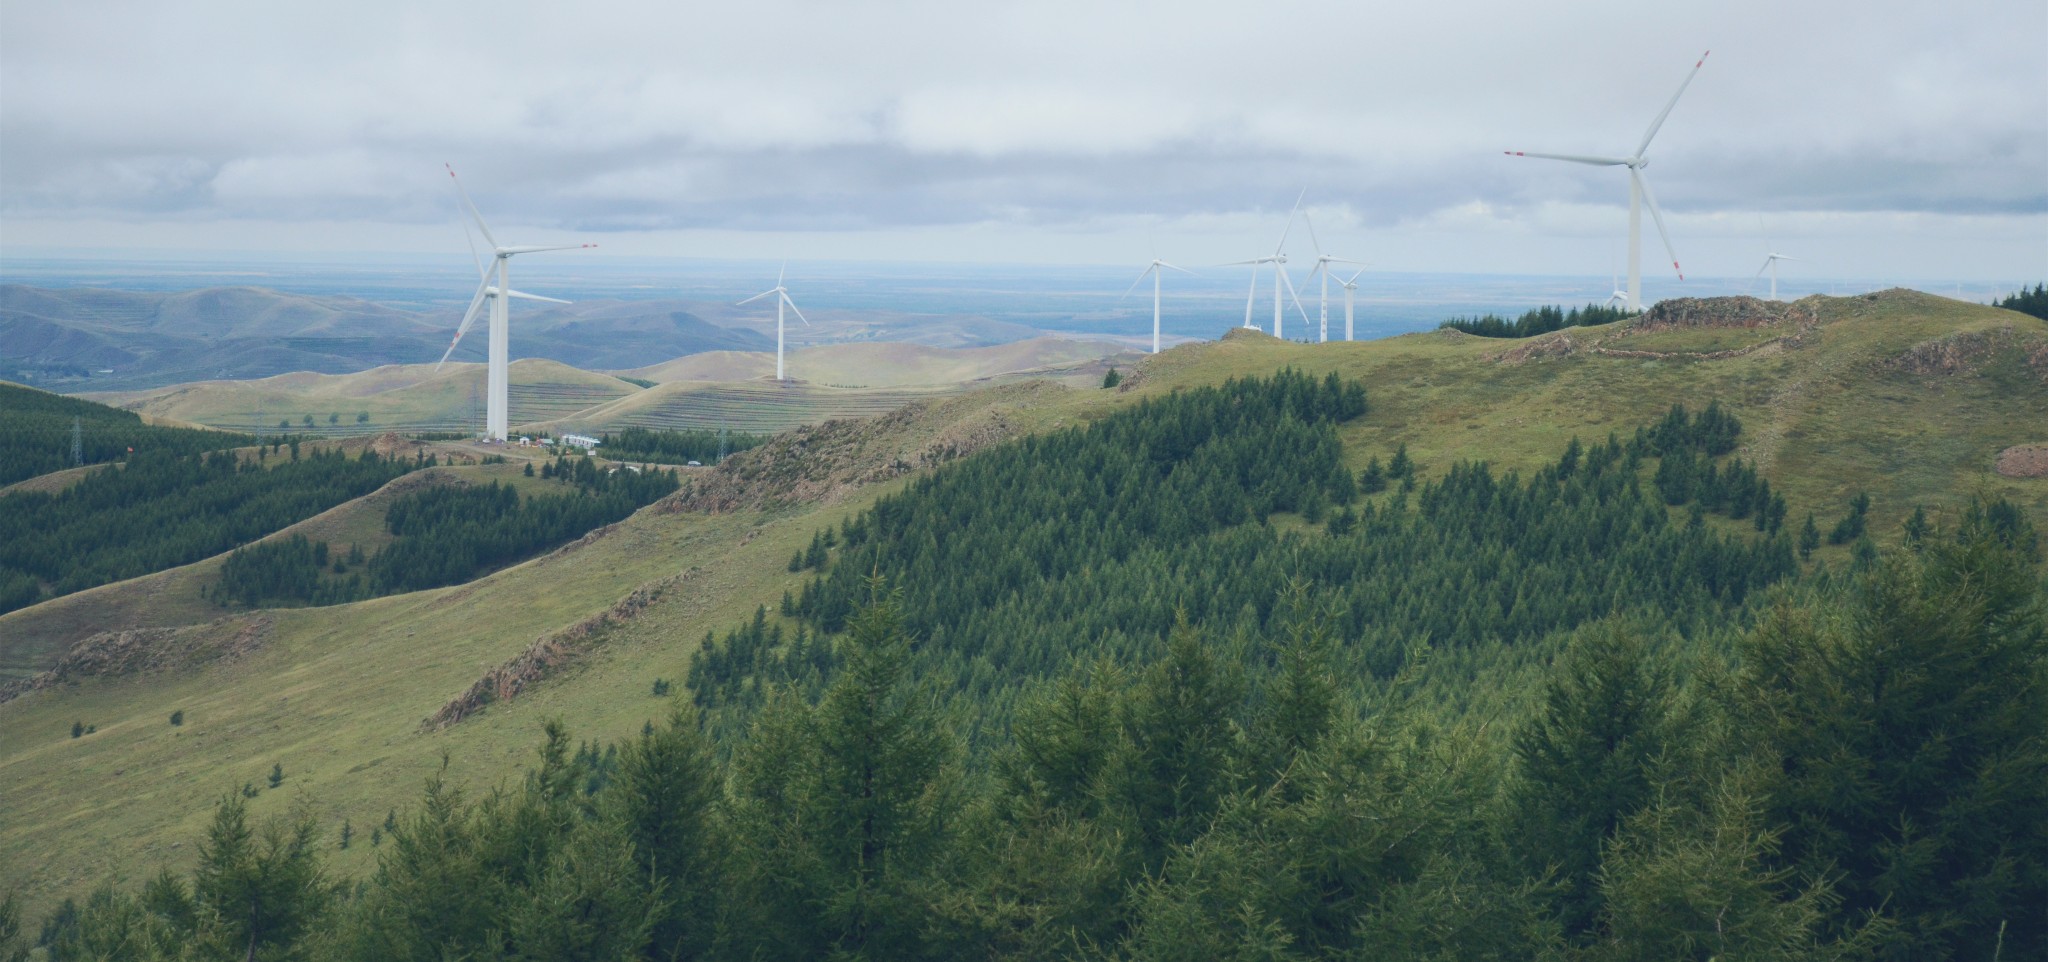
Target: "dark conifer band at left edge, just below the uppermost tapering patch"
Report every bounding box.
[0,450,418,610]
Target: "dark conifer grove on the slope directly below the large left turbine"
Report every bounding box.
[209,458,676,606]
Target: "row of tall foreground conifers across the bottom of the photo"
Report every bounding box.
[19,521,2048,962]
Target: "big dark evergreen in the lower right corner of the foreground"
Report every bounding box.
[1741,506,2048,960]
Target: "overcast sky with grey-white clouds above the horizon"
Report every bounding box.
[0,0,2048,280]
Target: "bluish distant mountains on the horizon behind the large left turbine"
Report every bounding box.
[0,285,774,391]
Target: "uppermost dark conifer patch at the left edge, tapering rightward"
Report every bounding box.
[0,385,256,487]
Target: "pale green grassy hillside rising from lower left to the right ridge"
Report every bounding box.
[0,291,2048,905]
